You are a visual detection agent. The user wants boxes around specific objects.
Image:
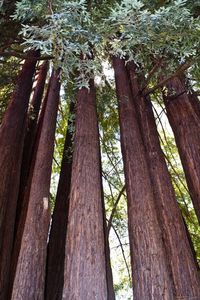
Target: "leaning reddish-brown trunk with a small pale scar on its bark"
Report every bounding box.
[11,70,60,300]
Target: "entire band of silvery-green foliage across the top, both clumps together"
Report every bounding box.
[14,0,200,92]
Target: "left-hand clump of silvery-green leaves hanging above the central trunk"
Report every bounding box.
[15,0,101,88]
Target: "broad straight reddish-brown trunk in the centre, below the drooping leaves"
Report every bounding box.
[62,80,107,300]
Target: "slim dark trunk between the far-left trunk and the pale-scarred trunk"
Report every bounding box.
[15,61,48,232]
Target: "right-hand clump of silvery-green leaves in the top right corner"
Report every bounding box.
[107,0,200,70]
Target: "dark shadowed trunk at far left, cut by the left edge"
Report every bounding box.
[0,51,38,299]
